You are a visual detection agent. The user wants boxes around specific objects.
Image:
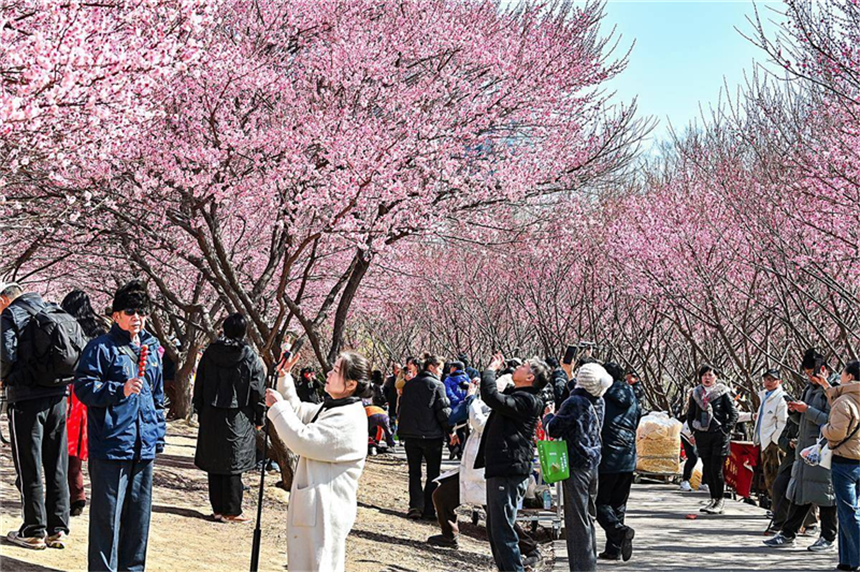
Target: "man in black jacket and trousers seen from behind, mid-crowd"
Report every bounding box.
[397,356,456,521]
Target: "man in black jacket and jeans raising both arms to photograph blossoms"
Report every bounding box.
[475,354,549,572]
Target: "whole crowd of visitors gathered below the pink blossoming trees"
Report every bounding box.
[0,281,860,571]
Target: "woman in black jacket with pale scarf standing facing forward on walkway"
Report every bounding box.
[687,365,738,514]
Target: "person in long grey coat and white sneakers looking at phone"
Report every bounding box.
[764,349,837,552]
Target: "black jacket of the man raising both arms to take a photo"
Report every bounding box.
[474,369,544,478]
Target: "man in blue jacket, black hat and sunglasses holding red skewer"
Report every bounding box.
[75,281,165,572]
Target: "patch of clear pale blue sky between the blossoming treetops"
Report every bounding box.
[601,0,781,140]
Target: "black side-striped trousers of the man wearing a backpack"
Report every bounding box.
[9,395,69,537]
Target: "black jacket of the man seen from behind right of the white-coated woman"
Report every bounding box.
[397,371,451,439]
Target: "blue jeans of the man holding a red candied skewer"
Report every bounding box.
[88,458,153,572]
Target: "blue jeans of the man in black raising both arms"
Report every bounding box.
[487,476,529,572]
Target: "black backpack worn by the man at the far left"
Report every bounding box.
[16,304,87,387]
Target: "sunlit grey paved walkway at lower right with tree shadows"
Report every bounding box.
[553,484,839,572]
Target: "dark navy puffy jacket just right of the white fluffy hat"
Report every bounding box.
[599,379,642,474]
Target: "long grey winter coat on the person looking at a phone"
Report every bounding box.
[786,383,836,506]
